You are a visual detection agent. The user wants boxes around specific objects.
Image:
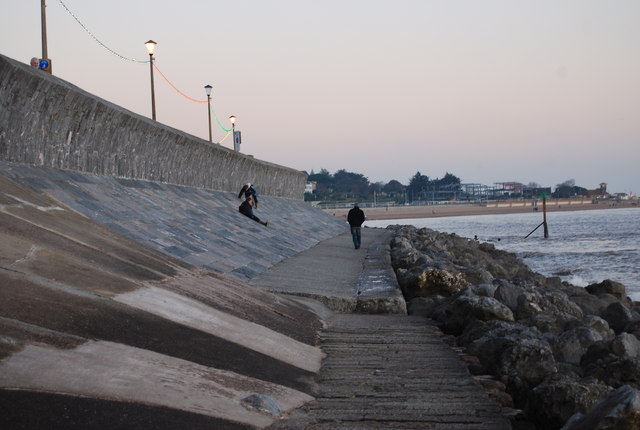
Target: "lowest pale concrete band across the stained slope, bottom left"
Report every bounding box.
[0,341,313,428]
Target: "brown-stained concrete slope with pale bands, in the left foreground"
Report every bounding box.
[0,176,330,429]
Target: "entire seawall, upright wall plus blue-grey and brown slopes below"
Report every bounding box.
[0,52,346,430]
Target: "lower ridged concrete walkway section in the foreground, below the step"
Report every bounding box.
[271,314,510,430]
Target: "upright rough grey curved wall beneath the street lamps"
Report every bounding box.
[0,55,306,199]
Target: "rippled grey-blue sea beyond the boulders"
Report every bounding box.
[365,208,640,301]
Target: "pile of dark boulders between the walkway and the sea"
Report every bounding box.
[389,226,640,430]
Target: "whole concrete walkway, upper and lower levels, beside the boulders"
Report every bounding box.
[250,229,510,430]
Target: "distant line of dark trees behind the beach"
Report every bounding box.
[304,169,595,203]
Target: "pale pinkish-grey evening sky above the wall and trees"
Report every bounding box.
[0,0,640,194]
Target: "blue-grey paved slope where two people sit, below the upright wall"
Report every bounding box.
[0,162,347,281]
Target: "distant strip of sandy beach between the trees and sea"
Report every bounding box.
[322,200,638,221]
